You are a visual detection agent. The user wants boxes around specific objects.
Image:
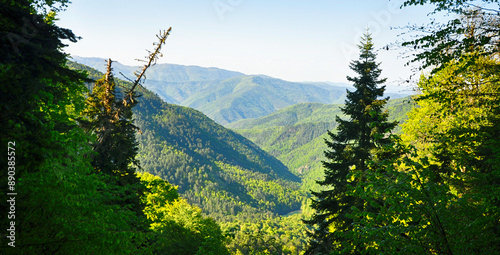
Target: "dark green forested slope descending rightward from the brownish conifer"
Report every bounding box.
[69,60,305,219]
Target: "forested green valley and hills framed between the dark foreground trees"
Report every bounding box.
[70,59,412,251]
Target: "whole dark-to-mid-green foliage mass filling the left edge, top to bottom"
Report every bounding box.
[0,1,149,254]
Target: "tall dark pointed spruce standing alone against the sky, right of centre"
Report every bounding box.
[304,32,397,254]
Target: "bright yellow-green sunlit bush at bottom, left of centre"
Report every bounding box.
[140,173,229,255]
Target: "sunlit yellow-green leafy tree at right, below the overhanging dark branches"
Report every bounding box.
[336,53,499,254]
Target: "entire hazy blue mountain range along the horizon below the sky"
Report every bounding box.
[73,56,352,124]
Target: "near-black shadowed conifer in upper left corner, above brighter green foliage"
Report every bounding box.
[0,1,84,175]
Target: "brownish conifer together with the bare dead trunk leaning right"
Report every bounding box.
[80,28,171,225]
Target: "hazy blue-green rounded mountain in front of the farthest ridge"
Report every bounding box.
[184,76,345,124]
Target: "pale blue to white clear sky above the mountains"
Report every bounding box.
[53,0,438,92]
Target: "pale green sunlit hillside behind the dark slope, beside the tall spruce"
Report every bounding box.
[227,98,413,191]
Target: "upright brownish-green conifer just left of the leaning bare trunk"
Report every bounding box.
[83,59,139,184]
